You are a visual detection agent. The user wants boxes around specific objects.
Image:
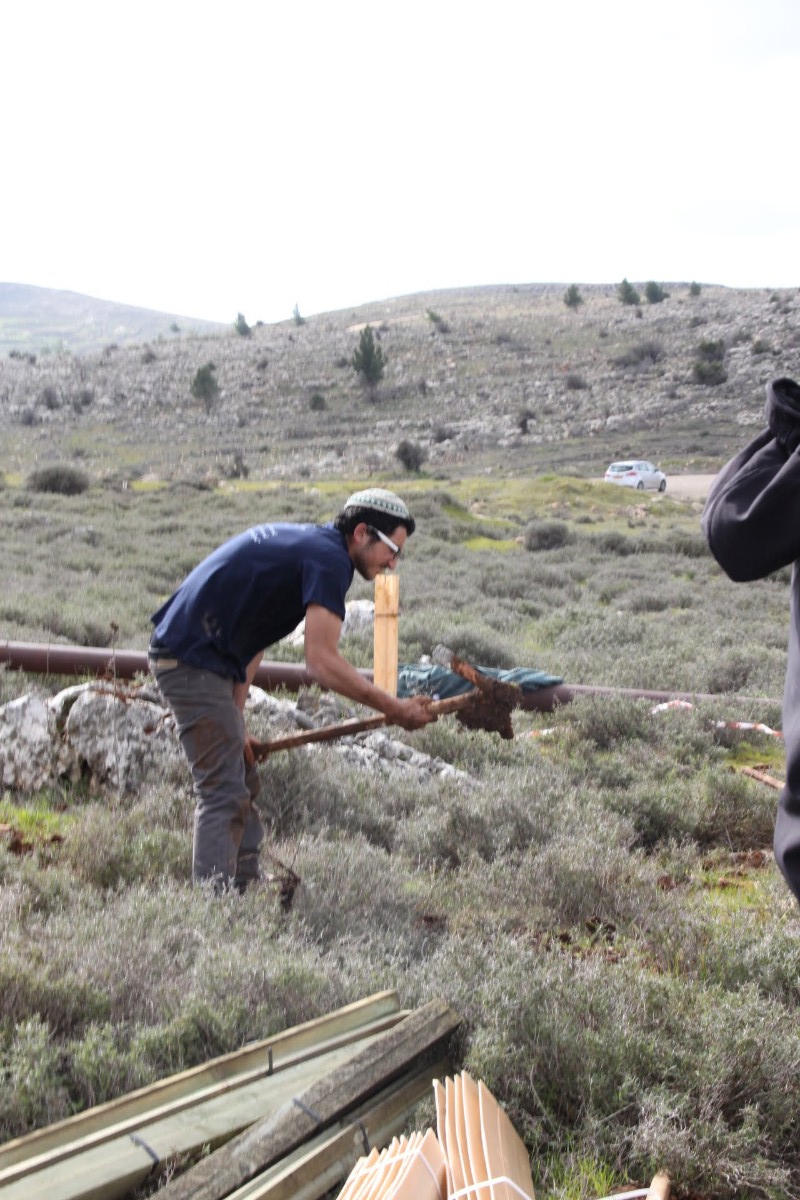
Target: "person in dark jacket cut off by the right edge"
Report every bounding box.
[703,379,800,901]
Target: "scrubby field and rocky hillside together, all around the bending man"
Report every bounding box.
[0,284,800,1200]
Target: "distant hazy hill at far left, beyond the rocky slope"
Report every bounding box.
[0,283,225,355]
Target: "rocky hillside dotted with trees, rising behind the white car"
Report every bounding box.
[0,283,800,481]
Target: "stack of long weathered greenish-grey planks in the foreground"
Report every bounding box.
[0,991,459,1200]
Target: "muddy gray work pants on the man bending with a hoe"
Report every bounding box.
[150,659,264,890]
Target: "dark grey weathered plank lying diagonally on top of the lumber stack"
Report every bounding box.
[160,1001,461,1200]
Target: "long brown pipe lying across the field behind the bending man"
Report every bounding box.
[0,642,780,713]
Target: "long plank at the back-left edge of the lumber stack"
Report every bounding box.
[0,990,401,1186]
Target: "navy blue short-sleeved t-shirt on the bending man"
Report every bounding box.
[150,524,354,683]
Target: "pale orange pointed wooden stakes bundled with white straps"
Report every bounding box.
[338,1070,534,1200]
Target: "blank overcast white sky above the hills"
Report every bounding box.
[0,0,800,324]
